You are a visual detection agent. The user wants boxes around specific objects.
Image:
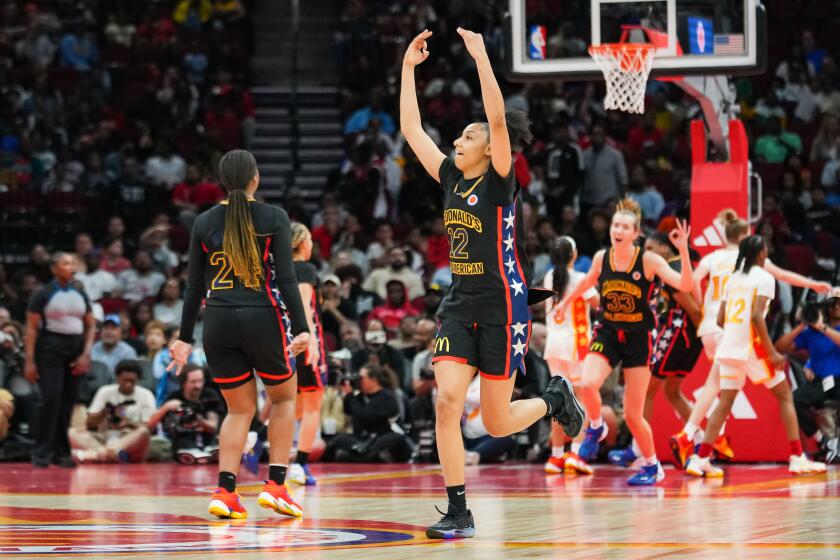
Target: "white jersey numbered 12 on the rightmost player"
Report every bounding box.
[715,266,776,360]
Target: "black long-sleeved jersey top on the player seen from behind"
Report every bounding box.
[180,201,309,342]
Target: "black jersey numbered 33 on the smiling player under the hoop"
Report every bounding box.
[598,247,656,331]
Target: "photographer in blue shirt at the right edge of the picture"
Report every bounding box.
[775,288,840,462]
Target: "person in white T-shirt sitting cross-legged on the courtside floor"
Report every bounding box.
[70,360,155,463]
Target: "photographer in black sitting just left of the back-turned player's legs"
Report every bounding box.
[149,364,223,465]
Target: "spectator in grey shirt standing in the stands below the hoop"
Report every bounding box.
[580,124,627,215]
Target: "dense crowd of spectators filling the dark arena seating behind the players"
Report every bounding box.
[0,0,840,462]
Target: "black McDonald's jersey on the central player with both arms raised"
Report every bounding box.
[438,158,531,324]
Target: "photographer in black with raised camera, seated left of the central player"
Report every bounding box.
[323,364,411,463]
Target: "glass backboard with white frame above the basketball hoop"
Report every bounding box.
[506,0,766,80]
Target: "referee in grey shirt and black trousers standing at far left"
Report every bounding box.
[24,253,95,468]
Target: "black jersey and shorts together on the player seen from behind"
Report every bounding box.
[180,190,309,389]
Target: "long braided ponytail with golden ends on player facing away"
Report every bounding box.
[219,150,263,290]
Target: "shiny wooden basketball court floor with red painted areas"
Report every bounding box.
[0,464,840,560]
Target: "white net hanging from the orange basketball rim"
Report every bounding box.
[589,43,655,113]
